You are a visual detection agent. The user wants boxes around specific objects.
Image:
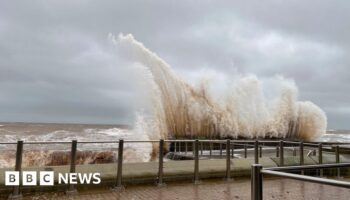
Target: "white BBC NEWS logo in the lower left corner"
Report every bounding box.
[5,171,101,186]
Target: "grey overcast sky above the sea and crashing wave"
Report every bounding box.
[0,0,350,129]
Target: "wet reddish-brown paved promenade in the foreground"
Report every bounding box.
[15,179,350,200]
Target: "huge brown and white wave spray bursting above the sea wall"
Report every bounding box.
[110,34,327,140]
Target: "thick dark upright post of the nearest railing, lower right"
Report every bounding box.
[251,164,263,200]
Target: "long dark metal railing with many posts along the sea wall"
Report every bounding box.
[0,139,350,197]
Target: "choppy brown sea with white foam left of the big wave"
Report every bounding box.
[0,123,152,167]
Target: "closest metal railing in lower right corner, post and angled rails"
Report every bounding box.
[251,163,350,200]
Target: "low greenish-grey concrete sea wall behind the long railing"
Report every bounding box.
[0,154,350,197]
